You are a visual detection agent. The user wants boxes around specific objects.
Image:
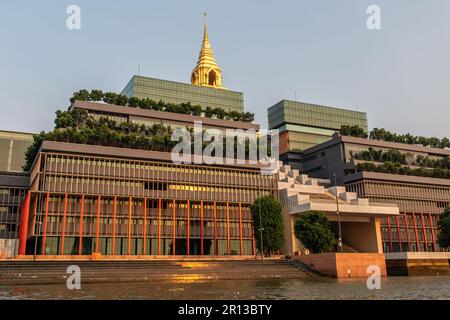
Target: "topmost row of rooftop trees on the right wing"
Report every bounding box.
[340,126,450,149]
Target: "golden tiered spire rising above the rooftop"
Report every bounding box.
[191,13,224,89]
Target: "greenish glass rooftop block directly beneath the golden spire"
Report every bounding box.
[122,76,244,112]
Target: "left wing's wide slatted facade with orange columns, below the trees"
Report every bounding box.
[20,142,274,255]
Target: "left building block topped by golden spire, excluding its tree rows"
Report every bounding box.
[18,16,276,256]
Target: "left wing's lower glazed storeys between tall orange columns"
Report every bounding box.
[27,193,254,256]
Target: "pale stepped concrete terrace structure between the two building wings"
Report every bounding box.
[277,165,399,256]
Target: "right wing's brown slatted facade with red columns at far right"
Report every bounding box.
[301,134,450,253]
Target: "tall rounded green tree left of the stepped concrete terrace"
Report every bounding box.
[251,197,284,255]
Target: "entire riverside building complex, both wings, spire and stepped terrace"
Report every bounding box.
[0,15,449,260]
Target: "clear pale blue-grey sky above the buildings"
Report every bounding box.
[0,0,450,137]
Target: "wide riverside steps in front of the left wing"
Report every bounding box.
[0,259,317,285]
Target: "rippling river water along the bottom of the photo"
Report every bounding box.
[0,276,450,300]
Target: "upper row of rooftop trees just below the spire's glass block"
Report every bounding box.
[70,90,255,122]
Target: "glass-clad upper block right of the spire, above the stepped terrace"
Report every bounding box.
[268,100,368,168]
